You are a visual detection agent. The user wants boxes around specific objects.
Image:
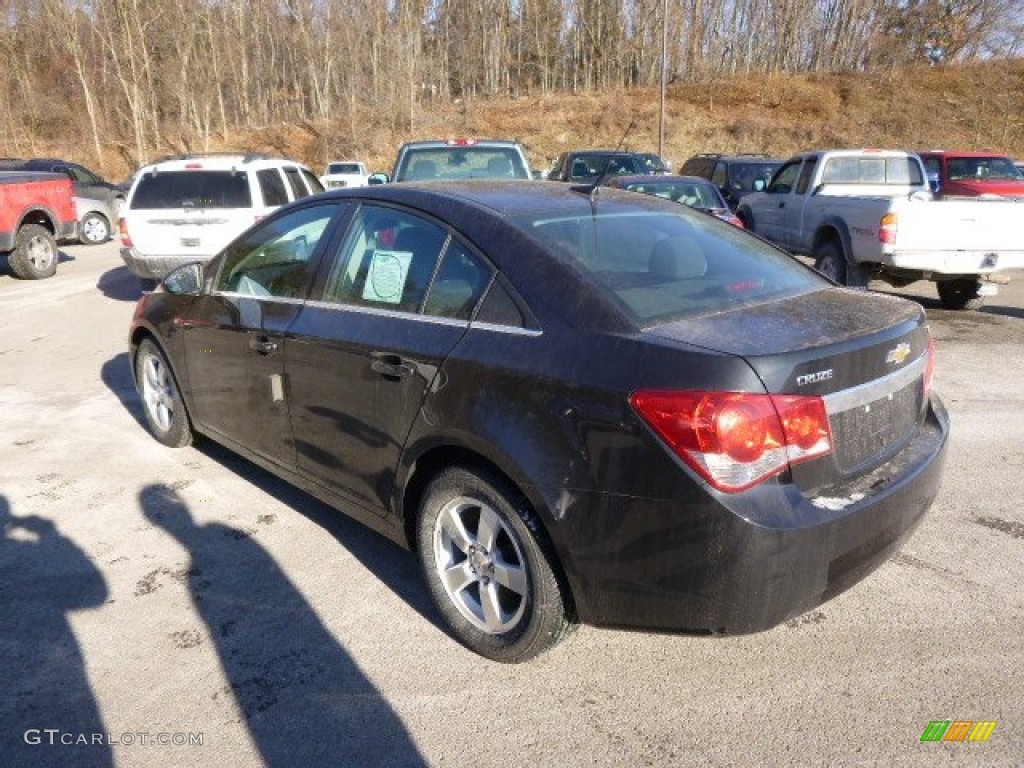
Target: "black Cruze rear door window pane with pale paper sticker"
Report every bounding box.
[323,205,450,312]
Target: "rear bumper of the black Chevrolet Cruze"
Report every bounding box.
[561,398,949,634]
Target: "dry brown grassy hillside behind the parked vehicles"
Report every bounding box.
[32,59,1024,178]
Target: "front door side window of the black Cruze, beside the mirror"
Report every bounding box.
[214,204,338,298]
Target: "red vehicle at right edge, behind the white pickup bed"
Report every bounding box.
[918,150,1024,200]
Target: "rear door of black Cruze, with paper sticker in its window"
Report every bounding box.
[285,204,492,514]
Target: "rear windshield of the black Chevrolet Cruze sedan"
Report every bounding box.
[521,207,828,328]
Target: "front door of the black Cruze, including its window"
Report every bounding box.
[183,201,347,467]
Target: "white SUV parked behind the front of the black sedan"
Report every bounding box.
[120,155,324,290]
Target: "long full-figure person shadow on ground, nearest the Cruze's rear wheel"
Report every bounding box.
[139,485,426,766]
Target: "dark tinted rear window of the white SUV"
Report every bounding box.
[131,170,253,210]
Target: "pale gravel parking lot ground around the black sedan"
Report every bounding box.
[0,243,1024,766]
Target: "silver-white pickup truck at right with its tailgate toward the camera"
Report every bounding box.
[736,150,1024,309]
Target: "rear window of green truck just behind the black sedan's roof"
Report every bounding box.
[395,146,529,181]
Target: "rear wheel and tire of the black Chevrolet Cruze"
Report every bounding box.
[417,467,574,664]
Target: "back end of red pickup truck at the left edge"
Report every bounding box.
[0,171,78,280]
